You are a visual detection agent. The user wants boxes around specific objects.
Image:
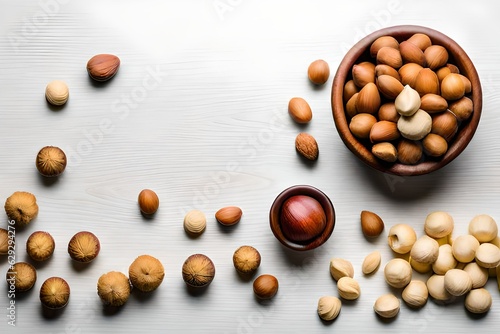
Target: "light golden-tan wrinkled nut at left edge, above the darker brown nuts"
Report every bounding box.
[5,191,38,227]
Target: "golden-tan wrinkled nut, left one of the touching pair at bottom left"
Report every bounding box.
[97,271,132,306]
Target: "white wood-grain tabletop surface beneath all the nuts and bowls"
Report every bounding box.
[0,0,500,333]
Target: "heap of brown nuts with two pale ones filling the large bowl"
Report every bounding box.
[343,33,473,165]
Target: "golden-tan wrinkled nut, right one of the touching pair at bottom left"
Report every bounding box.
[128,255,165,292]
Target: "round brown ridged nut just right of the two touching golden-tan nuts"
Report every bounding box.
[182,254,215,288]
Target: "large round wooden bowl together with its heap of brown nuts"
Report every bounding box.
[332,25,482,176]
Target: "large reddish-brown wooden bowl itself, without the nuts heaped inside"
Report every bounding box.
[331,25,482,176]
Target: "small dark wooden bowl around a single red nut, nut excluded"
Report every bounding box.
[269,185,335,251]
